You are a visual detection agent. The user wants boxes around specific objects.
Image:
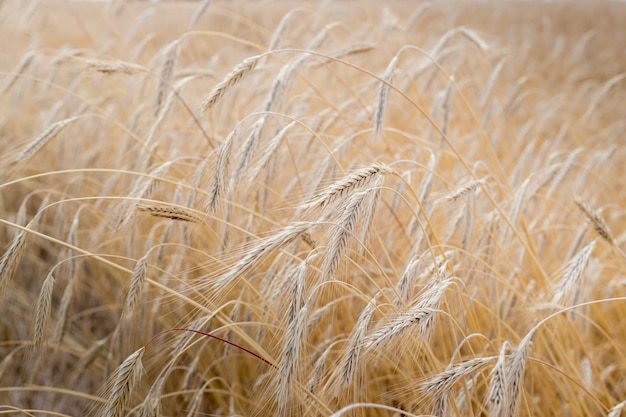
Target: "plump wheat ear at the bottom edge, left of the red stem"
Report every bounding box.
[103,346,145,417]
